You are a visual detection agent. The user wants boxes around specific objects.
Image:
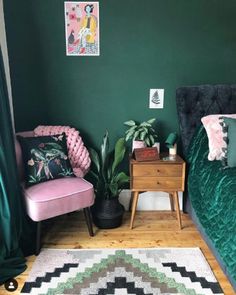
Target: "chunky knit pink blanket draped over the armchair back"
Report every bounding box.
[34,125,91,177]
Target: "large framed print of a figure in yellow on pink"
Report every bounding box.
[64,1,100,56]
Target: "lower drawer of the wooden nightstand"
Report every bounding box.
[132,177,183,191]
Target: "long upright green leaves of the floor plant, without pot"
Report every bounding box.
[89,131,129,199]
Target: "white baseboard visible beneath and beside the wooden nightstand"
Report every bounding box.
[119,190,183,211]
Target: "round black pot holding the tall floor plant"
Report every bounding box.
[92,198,125,229]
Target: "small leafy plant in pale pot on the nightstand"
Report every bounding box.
[124,118,157,150]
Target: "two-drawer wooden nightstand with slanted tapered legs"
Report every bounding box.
[130,155,185,229]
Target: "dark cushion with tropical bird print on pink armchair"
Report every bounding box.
[17,133,74,186]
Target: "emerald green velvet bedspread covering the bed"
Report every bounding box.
[188,126,236,281]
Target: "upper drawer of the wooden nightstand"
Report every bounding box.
[133,164,183,177]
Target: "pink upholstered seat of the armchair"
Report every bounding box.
[24,177,94,221]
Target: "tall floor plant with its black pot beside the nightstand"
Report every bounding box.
[90,131,129,228]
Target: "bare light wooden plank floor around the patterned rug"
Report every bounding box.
[0,211,235,295]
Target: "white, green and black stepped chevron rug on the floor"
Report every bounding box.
[21,248,223,295]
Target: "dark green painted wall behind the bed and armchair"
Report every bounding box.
[5,0,236,150]
